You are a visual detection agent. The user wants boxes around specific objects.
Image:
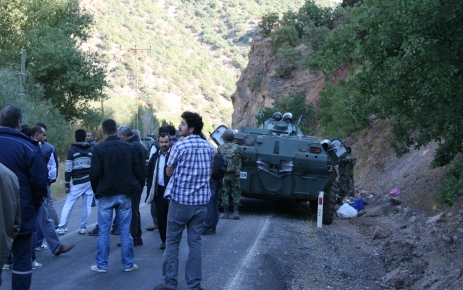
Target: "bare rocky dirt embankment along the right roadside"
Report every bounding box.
[293,116,463,289]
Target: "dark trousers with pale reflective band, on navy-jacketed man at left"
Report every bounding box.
[11,233,32,290]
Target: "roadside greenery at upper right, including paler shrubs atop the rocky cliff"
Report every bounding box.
[259,0,463,205]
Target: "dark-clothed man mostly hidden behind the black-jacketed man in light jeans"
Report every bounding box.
[117,126,146,246]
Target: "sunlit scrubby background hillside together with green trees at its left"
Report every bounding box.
[0,0,312,155]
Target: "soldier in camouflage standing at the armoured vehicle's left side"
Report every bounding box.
[218,129,246,219]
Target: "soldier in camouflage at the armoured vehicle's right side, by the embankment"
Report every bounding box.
[338,147,357,198]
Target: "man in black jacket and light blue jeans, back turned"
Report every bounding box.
[90,119,142,273]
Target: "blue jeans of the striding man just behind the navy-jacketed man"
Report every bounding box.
[34,198,61,257]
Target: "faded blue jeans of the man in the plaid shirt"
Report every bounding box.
[162,200,206,289]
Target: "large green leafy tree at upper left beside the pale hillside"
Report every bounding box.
[0,0,106,121]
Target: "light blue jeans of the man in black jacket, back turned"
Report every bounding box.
[96,194,134,269]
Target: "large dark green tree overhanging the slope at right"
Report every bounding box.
[318,0,463,204]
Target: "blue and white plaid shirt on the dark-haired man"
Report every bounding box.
[164,135,214,205]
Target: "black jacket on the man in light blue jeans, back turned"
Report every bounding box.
[90,136,142,198]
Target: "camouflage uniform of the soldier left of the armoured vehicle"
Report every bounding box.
[218,141,246,207]
